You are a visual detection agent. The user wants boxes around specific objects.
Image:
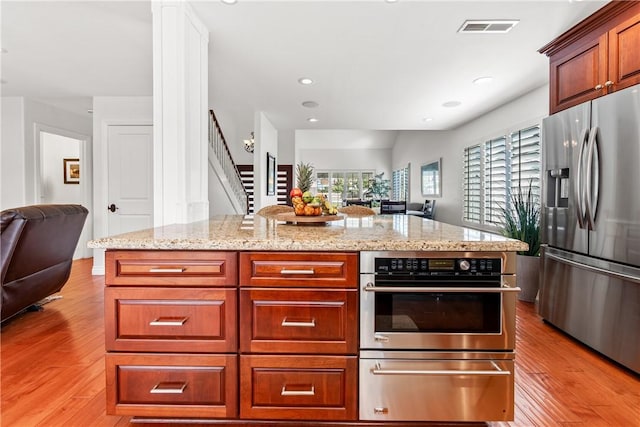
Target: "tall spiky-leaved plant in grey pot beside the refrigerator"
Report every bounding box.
[502,181,540,302]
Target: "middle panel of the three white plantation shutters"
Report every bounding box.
[484,136,509,224]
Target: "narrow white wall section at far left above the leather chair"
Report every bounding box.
[0,97,26,210]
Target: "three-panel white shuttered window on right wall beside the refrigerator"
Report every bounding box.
[463,125,541,226]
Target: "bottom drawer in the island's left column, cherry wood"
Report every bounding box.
[106,353,238,418]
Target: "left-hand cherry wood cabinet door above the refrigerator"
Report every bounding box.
[549,34,608,113]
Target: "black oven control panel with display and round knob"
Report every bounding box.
[375,258,501,276]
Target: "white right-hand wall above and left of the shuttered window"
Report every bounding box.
[393,85,549,226]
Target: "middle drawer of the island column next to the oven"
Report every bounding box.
[240,289,358,354]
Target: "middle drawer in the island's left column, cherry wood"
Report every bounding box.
[104,287,238,353]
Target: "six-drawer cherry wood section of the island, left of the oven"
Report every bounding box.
[105,250,359,425]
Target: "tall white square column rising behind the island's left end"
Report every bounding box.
[152,0,209,226]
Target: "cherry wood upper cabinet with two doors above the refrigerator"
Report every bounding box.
[539,1,640,114]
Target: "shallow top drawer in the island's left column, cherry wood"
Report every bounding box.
[105,251,238,287]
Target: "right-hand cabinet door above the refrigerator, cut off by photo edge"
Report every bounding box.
[609,15,640,90]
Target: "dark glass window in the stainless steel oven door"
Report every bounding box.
[375,292,501,333]
